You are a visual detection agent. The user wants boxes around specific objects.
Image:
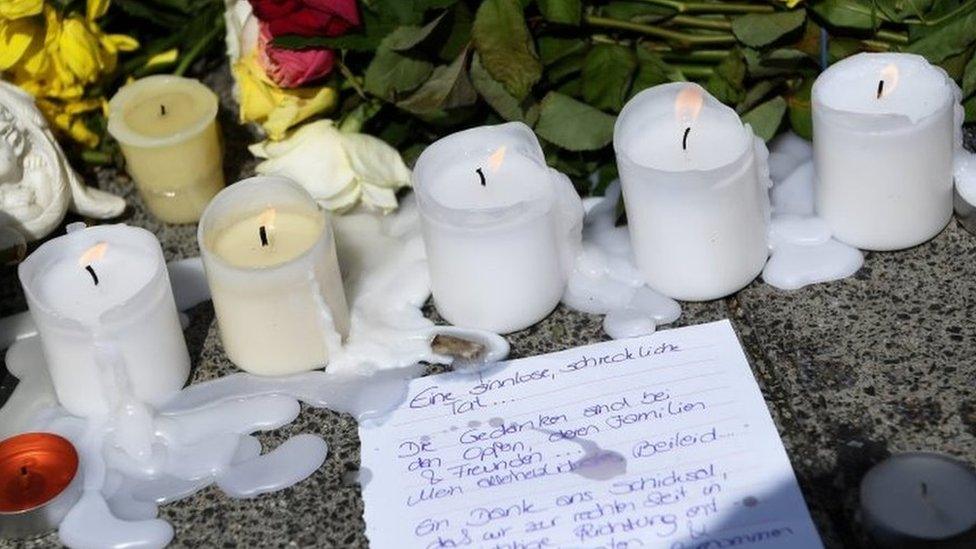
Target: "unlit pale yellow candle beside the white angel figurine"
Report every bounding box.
[108,75,224,223]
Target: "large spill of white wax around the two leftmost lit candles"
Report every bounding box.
[0,200,508,548]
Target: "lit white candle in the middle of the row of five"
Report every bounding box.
[413,122,583,333]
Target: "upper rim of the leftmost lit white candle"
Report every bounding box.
[17,223,169,329]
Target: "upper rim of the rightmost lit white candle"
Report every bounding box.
[810,52,960,124]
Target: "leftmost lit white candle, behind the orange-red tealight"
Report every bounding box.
[19,225,190,416]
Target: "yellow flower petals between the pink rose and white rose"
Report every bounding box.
[233,52,337,140]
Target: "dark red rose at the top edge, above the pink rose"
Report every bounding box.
[250,0,359,36]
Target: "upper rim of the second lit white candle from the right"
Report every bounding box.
[613,82,754,175]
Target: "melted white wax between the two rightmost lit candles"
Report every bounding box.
[762,133,864,290]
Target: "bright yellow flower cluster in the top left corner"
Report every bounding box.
[0,0,139,146]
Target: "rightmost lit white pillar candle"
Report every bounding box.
[813,53,962,250]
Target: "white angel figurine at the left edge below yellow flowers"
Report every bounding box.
[0,81,125,241]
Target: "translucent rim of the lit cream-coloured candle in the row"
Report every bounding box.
[197,175,335,273]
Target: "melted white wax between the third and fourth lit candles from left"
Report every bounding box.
[563,182,681,339]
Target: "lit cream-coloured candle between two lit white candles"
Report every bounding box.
[197,177,349,375]
